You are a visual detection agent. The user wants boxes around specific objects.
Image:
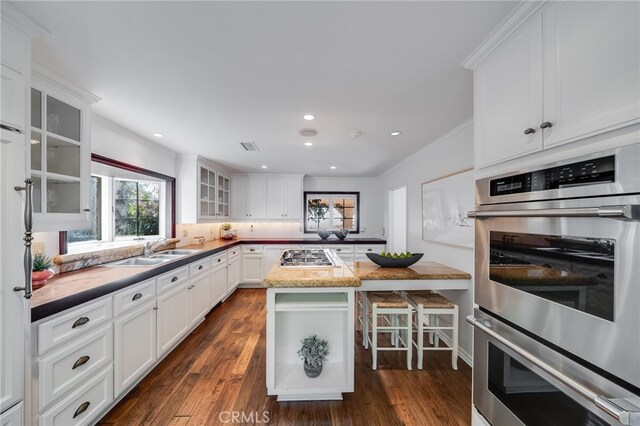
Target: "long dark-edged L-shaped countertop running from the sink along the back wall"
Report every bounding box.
[31,238,386,321]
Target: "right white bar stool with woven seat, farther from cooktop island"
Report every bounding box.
[406,291,458,370]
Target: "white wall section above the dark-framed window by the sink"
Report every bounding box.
[91,114,177,177]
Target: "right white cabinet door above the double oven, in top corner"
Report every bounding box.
[542,2,640,148]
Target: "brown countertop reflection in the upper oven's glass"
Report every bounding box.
[489,265,598,289]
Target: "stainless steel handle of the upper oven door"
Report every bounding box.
[467,204,640,220]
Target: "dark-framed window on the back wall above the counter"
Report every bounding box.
[304,192,360,233]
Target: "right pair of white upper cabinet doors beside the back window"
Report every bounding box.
[267,176,303,220]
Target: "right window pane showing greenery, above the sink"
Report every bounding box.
[114,179,160,237]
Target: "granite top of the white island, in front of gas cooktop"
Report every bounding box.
[262,265,361,287]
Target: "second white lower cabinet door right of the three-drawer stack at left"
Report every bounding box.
[156,281,191,357]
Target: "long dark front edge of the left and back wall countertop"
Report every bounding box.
[31,238,386,323]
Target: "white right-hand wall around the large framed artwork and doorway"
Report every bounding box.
[378,120,474,362]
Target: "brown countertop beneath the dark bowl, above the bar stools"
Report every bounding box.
[353,260,471,281]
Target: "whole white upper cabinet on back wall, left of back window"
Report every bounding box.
[231,175,303,220]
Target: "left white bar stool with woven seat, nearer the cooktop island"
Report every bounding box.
[363,292,413,370]
